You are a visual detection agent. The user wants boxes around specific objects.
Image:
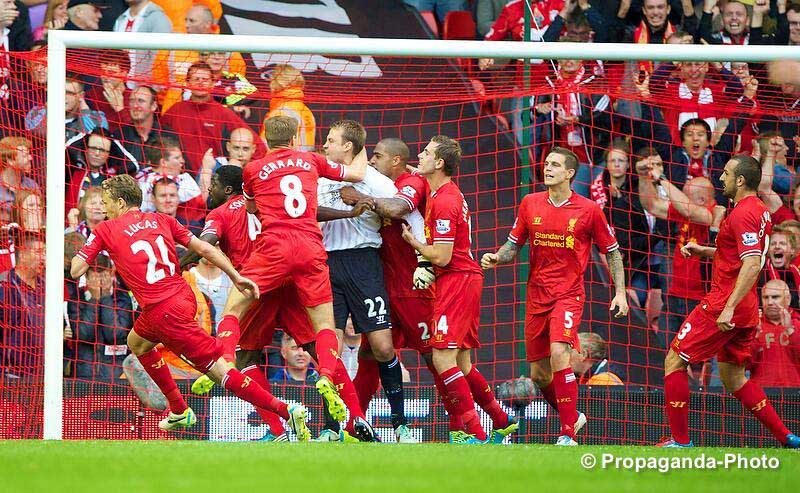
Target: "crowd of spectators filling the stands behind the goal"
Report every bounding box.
[0,0,800,392]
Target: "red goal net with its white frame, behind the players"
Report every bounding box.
[0,28,800,446]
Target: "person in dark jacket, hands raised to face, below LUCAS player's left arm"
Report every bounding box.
[73,255,133,382]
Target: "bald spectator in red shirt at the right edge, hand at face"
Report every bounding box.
[750,279,800,387]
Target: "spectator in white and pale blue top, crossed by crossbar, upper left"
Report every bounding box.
[114,0,172,84]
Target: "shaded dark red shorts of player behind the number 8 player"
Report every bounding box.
[239,285,315,351]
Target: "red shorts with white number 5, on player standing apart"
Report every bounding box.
[525,296,583,361]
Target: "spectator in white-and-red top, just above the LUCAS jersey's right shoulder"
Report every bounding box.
[136,139,206,223]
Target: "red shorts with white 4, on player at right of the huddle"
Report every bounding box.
[430,272,483,349]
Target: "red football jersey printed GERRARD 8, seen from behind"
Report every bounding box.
[242,149,346,239]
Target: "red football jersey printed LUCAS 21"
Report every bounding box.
[77,210,194,308]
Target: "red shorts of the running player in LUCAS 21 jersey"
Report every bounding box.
[133,285,223,373]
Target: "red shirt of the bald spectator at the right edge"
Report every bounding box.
[750,312,800,387]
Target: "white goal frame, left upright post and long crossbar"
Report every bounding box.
[43,30,800,440]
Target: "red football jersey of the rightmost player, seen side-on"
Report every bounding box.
[702,195,772,327]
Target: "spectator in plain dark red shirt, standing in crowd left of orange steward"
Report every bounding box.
[161,62,265,176]
